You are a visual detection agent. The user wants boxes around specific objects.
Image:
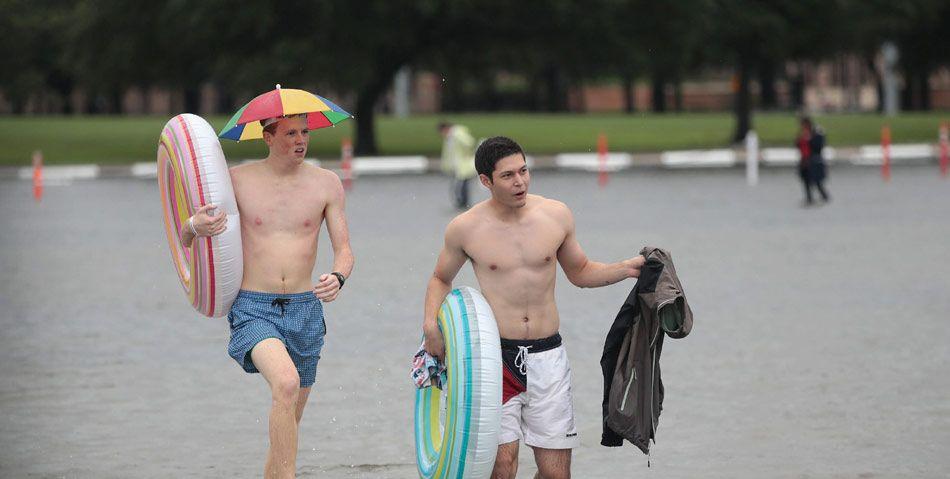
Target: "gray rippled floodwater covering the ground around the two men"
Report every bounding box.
[0,167,950,478]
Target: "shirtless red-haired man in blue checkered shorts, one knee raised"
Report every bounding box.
[181,115,354,478]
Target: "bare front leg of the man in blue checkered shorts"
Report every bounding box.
[251,338,303,478]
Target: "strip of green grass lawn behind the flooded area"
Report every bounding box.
[0,112,950,166]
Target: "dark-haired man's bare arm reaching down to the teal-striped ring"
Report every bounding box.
[422,218,467,358]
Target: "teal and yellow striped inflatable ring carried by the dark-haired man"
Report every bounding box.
[415,287,502,479]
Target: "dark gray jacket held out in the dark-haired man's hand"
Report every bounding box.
[600,247,693,454]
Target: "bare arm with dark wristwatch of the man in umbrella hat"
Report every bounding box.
[314,173,356,301]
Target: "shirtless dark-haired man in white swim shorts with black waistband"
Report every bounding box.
[422,137,644,479]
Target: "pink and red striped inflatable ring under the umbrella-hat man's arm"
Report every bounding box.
[158,113,244,317]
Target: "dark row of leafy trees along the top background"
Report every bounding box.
[0,0,950,154]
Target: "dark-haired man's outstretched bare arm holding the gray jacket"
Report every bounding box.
[555,205,645,288]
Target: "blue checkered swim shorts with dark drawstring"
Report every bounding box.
[228,290,327,388]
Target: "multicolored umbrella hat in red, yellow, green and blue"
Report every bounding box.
[218,84,353,141]
